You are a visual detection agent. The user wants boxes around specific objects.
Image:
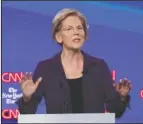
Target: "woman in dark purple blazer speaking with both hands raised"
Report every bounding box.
[17,9,131,117]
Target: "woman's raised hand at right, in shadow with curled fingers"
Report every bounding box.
[113,78,132,96]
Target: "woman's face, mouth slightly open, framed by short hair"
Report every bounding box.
[56,16,85,50]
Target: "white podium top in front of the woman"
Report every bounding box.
[18,113,115,123]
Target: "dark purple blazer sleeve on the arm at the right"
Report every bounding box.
[101,60,129,118]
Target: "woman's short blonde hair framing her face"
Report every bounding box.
[52,9,88,40]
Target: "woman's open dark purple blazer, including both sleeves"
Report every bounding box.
[16,51,127,117]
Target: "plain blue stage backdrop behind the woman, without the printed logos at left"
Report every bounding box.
[2,1,143,122]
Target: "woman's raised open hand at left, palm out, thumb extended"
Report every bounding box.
[20,73,42,102]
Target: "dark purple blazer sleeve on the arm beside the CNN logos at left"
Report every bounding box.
[16,63,43,114]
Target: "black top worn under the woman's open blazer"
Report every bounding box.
[68,78,83,113]
